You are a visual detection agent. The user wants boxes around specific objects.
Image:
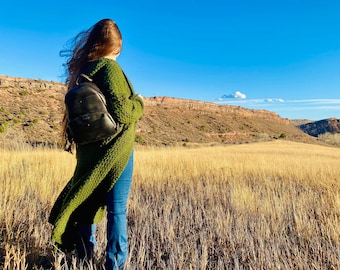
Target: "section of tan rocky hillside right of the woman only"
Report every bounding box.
[138,97,314,145]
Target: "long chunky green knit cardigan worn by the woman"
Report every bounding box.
[49,58,144,250]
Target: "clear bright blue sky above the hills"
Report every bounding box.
[0,0,340,120]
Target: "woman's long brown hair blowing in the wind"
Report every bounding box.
[60,19,122,148]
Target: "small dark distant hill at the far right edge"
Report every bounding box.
[298,118,340,137]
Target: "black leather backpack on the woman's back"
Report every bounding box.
[65,74,119,144]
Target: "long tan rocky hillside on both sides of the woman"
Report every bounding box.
[0,75,316,148]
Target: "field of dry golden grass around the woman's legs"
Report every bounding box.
[0,141,340,269]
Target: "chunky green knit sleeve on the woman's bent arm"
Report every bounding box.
[91,59,144,124]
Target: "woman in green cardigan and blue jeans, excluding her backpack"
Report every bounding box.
[49,19,144,269]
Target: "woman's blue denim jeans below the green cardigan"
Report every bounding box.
[76,152,133,269]
